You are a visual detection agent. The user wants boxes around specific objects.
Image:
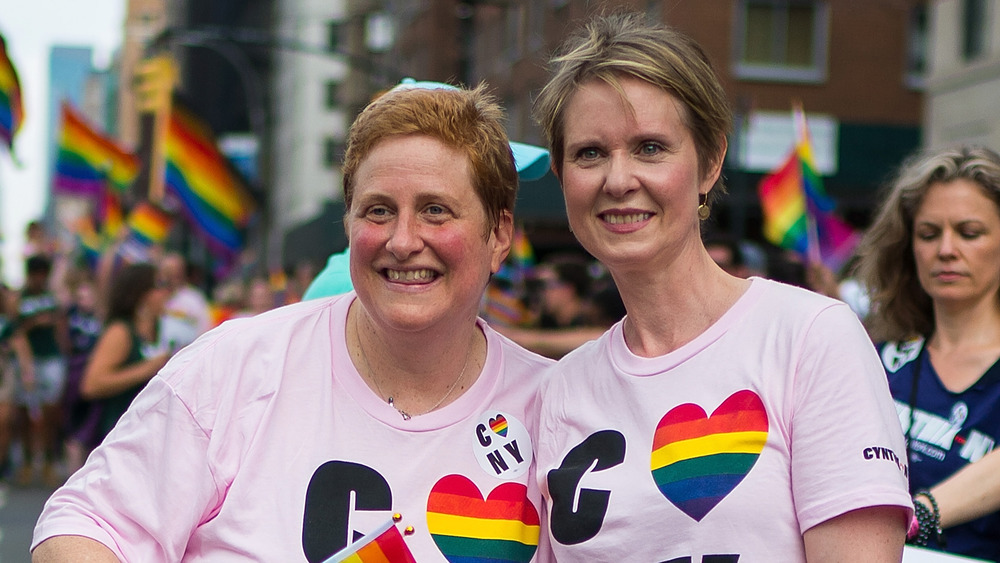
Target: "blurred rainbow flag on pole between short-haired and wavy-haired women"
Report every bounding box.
[757,106,861,271]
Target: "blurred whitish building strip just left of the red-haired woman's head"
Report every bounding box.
[271,0,350,266]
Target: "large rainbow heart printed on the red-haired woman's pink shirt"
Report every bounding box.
[427,475,539,563]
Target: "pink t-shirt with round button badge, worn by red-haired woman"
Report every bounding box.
[32,293,551,563]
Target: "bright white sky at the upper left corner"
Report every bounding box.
[0,0,126,287]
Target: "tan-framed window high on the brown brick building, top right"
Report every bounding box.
[734,0,830,82]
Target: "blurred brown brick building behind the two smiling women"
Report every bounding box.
[338,0,928,256]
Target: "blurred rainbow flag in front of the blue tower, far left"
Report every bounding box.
[53,102,140,198]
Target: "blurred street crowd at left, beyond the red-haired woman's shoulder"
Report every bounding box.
[0,236,298,487]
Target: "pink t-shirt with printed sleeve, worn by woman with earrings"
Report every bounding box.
[538,278,910,563]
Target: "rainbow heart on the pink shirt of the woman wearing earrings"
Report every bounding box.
[650,389,768,522]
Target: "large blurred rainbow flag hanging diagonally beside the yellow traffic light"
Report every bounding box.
[165,102,256,256]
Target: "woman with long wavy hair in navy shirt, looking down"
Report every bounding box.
[858,146,1000,561]
